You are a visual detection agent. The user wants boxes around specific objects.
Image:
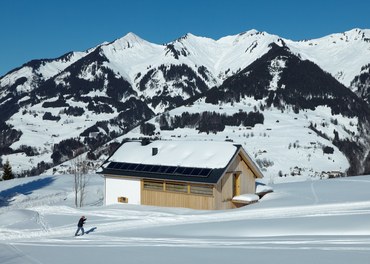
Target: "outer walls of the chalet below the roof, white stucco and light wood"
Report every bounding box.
[101,141,262,210]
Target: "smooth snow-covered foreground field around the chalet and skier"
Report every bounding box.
[0,175,370,264]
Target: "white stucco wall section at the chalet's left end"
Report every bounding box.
[105,177,141,205]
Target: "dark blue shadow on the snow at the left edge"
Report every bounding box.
[0,177,54,207]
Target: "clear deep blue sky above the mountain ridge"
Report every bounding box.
[0,0,370,76]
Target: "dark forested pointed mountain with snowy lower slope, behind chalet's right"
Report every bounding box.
[125,44,370,178]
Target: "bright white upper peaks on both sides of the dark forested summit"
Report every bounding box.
[97,29,370,86]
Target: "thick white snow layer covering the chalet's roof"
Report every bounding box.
[108,141,237,169]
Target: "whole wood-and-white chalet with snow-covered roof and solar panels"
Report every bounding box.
[99,141,263,210]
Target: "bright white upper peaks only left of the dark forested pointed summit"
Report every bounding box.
[102,30,279,85]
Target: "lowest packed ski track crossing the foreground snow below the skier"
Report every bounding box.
[7,236,370,251]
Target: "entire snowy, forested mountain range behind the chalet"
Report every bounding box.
[0,29,370,181]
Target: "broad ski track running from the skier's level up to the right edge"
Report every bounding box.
[0,201,370,244]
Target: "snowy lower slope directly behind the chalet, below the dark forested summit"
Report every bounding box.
[123,99,357,182]
